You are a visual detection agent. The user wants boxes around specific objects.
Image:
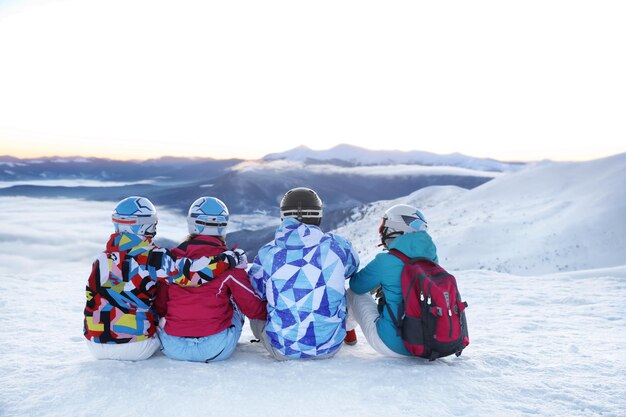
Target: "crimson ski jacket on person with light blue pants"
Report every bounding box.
[155,235,267,337]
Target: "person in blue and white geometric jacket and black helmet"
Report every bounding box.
[248,187,359,360]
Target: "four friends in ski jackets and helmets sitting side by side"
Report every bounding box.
[84,188,437,362]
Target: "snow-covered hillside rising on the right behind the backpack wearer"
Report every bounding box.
[338,154,626,274]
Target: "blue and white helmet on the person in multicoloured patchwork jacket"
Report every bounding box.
[111,196,158,236]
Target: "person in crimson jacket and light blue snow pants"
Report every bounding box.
[155,197,266,362]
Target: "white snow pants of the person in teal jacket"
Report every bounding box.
[346,289,406,358]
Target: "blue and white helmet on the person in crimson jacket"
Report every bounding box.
[187,197,228,236]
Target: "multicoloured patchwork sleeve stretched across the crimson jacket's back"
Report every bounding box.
[148,248,230,287]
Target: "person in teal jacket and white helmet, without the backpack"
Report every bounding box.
[345,204,438,357]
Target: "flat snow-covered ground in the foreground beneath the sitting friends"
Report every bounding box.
[0,260,626,416]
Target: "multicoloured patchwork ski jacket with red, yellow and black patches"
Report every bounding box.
[83,233,228,343]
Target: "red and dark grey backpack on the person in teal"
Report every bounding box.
[385,249,469,360]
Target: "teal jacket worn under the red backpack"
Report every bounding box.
[350,232,439,356]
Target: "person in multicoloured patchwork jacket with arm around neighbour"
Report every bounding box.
[83,196,236,360]
